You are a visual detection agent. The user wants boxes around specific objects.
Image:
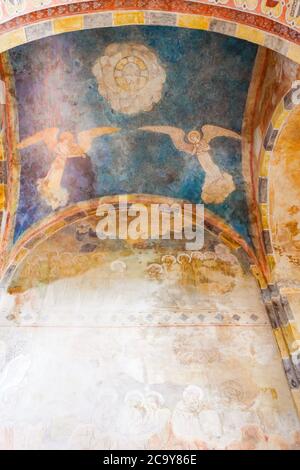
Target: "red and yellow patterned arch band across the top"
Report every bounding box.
[0,5,300,63]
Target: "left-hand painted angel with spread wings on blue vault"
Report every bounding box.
[18,127,119,210]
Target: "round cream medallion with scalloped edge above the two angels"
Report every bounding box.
[93,43,166,114]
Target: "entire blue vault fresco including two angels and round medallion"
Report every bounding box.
[10,26,256,240]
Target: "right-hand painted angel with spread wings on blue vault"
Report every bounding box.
[140,125,241,204]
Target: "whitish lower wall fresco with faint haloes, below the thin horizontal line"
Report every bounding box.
[0,324,300,450]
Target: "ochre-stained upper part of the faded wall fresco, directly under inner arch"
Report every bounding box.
[8,215,256,300]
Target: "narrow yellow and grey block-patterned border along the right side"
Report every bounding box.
[253,82,300,415]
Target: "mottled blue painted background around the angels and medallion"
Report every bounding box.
[10,26,257,241]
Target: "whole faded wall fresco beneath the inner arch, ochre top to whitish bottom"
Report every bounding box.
[0,233,300,450]
